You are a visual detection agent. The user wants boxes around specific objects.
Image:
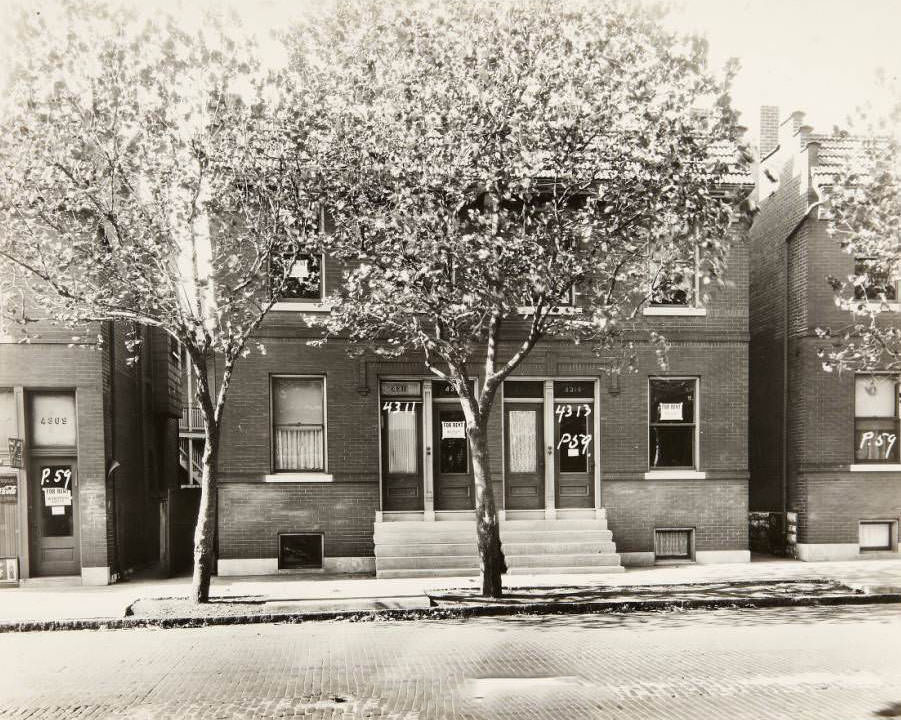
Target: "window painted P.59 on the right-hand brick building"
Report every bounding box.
[854,375,898,464]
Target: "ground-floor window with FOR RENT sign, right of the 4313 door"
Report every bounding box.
[648,378,698,470]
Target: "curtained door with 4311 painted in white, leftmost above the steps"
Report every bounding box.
[381,400,423,511]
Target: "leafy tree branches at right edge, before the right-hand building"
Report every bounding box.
[817,89,901,372]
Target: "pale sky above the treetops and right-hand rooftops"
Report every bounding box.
[0,0,901,145]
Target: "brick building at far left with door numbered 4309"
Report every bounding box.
[0,316,185,585]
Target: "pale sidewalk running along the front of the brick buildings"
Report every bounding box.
[0,558,901,625]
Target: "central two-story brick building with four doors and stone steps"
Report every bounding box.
[211,181,750,577]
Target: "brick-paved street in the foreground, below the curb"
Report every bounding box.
[0,605,901,720]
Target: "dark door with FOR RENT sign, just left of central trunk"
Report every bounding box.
[432,402,475,510]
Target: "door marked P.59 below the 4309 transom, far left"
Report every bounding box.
[28,457,80,575]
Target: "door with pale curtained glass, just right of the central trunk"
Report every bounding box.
[504,403,544,510]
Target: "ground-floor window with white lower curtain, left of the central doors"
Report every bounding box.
[272,377,325,472]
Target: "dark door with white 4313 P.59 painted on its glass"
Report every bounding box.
[554,400,594,508]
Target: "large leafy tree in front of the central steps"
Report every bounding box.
[293,0,738,597]
